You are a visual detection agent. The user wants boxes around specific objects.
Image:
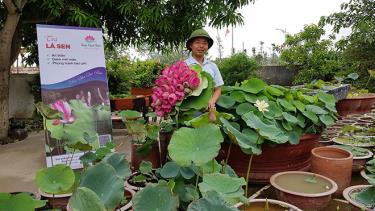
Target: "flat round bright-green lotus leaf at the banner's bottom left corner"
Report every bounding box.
[36,164,75,194]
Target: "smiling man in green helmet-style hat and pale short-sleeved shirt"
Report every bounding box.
[185,29,224,110]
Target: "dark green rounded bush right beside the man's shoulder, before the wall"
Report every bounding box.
[217,53,259,86]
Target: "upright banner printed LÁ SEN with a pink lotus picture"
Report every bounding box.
[37,24,112,169]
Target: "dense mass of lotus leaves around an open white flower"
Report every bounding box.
[217,78,336,152]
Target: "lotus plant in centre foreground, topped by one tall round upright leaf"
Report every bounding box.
[133,124,246,211]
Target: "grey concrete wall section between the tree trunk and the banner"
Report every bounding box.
[9,74,37,119]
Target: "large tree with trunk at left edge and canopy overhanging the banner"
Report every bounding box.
[0,0,254,142]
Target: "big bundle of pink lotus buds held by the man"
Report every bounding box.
[151,60,201,117]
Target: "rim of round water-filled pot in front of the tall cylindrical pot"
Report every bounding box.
[270,171,338,198]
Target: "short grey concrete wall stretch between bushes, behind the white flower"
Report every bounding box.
[258,66,298,86]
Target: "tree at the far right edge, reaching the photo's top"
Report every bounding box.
[320,0,375,91]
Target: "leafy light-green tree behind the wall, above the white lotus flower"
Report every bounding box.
[280,24,342,84]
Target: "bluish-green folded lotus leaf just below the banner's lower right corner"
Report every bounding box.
[103,152,132,179]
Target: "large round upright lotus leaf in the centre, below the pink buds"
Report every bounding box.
[168,124,224,166]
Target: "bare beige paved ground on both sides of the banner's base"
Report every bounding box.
[0,129,130,193]
